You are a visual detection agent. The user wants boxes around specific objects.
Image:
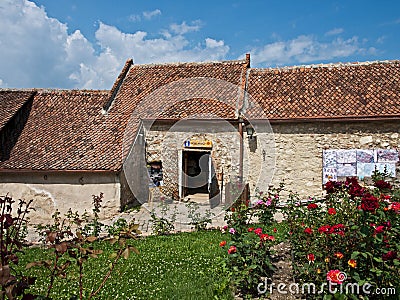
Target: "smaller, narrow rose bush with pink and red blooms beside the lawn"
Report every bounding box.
[221,185,283,297]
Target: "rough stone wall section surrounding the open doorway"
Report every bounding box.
[145,121,240,198]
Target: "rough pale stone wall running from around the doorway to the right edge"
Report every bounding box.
[146,121,400,202]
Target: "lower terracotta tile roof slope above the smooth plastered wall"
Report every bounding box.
[0,90,119,170]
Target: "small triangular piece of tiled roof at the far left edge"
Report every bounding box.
[0,90,35,130]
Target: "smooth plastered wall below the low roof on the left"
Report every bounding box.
[0,172,121,224]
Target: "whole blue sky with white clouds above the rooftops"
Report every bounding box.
[0,0,400,89]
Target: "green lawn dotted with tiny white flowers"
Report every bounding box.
[19,231,232,299]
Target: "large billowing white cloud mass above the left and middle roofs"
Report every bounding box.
[0,0,229,89]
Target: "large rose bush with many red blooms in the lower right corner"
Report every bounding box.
[286,173,400,299]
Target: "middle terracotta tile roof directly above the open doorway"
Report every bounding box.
[107,60,249,156]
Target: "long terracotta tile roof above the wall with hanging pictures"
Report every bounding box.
[247,61,400,120]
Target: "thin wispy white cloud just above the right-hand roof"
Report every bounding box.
[245,35,368,66]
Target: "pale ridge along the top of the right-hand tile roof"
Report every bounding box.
[250,60,400,71]
